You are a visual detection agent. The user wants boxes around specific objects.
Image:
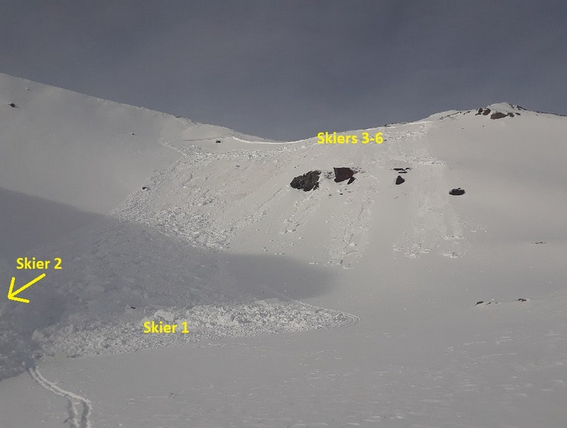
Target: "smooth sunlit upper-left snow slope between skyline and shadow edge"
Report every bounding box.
[0,74,178,214]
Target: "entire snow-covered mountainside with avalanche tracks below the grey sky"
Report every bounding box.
[0,75,567,428]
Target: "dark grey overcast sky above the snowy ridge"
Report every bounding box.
[0,0,567,140]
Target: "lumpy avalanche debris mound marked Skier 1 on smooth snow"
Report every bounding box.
[34,298,357,359]
